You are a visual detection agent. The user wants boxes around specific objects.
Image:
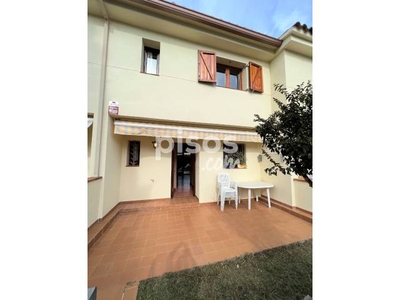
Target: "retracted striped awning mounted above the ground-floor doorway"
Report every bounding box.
[114,121,261,143]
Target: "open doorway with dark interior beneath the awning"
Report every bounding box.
[171,143,196,198]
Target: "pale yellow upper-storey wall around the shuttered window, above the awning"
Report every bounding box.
[106,22,271,126]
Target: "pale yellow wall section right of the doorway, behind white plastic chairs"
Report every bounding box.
[198,143,261,203]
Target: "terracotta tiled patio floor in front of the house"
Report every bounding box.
[88,198,312,300]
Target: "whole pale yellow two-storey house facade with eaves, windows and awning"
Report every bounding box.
[88,0,312,226]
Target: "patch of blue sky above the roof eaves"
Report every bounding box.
[168,0,312,38]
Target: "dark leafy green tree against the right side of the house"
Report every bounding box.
[254,81,313,187]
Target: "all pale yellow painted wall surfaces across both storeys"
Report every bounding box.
[88,9,312,225]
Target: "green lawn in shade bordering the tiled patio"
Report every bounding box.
[137,239,312,300]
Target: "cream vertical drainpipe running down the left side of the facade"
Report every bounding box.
[95,0,110,176]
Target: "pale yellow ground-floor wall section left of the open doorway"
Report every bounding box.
[119,136,171,201]
